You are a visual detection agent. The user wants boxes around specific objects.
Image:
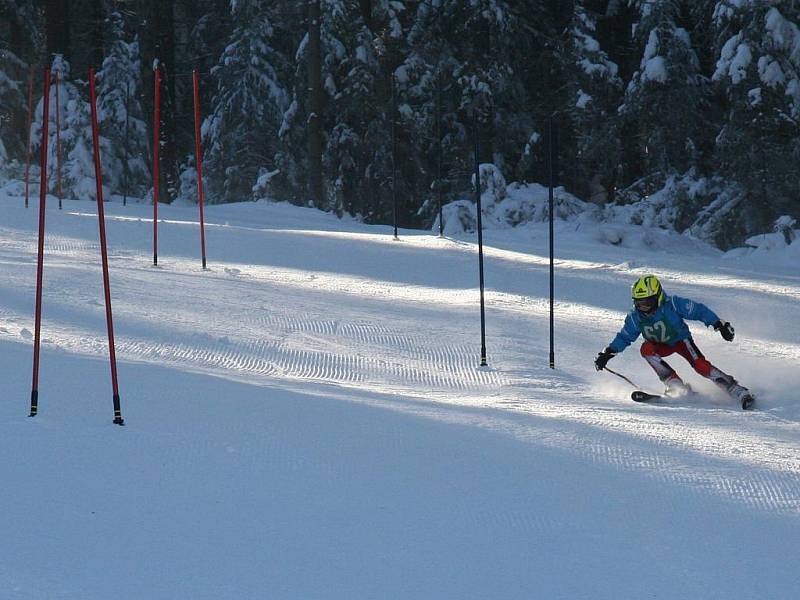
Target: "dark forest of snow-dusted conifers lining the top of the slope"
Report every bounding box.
[0,0,800,247]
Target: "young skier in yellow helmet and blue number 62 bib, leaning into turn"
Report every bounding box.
[594,275,753,408]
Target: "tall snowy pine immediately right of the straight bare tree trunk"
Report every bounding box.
[321,0,398,221]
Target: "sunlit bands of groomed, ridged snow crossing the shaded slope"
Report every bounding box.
[0,207,800,519]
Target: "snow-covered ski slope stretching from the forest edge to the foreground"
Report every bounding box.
[0,189,800,600]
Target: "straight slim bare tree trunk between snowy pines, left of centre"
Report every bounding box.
[308,0,324,208]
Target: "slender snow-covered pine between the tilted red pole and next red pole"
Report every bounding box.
[97,11,150,197]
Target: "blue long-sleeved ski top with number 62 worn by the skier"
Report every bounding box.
[608,294,719,353]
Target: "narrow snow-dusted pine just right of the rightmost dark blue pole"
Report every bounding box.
[561,0,622,203]
